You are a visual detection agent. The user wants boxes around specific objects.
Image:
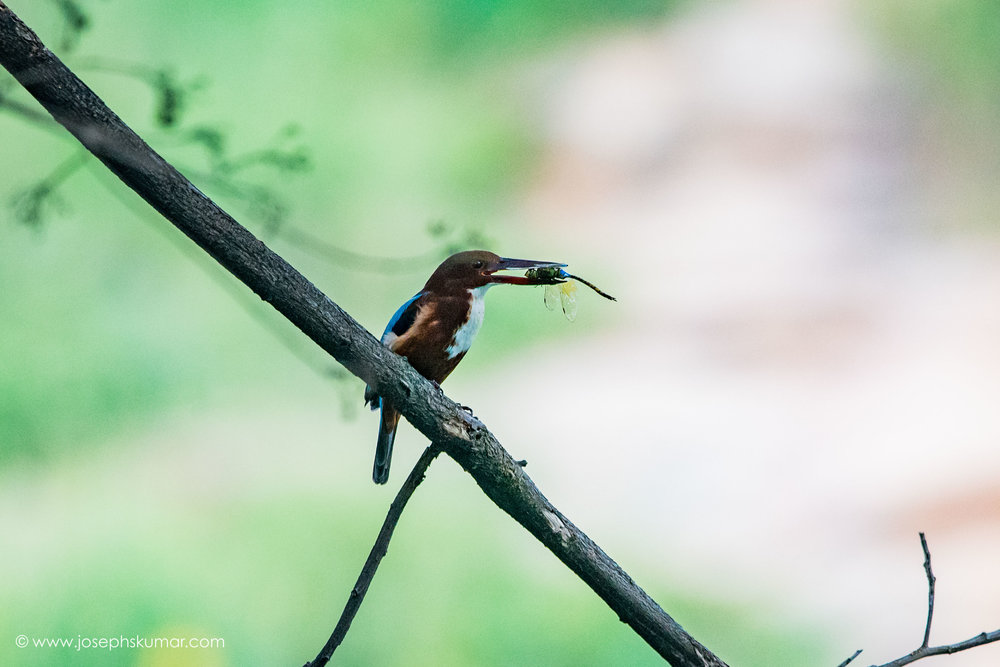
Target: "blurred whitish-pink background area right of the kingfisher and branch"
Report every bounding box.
[464,0,1000,667]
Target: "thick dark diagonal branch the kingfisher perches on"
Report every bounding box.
[0,2,725,667]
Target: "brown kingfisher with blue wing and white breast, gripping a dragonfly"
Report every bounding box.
[365,250,566,484]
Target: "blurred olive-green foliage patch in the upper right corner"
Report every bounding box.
[858,0,1000,236]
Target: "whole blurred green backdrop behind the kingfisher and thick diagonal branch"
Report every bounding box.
[0,0,1000,666]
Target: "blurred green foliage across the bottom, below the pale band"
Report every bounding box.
[0,443,835,667]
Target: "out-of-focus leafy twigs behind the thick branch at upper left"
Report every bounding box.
[0,0,491,264]
